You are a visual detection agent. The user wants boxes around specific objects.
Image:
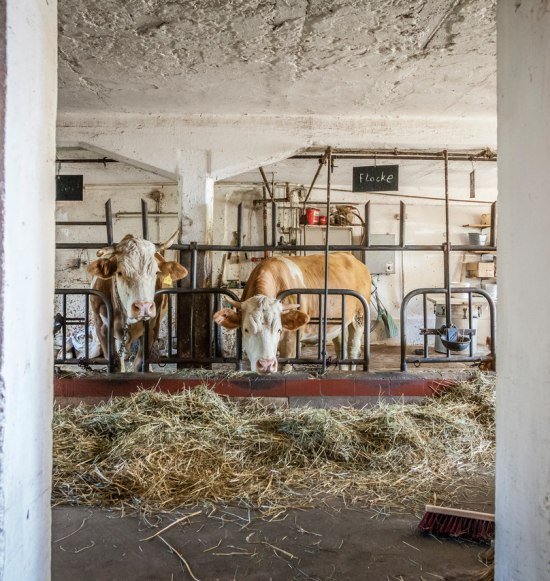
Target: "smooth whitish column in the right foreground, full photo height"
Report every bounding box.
[496,0,550,581]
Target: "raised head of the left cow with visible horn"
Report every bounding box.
[88,232,187,325]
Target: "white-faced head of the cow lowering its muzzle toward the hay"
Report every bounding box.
[214,295,309,373]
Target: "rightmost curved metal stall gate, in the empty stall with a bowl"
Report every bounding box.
[400,287,496,371]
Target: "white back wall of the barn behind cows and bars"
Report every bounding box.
[56,160,496,354]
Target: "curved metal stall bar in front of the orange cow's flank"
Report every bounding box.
[277,288,370,371]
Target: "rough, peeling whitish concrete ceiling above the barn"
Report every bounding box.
[58,0,496,117]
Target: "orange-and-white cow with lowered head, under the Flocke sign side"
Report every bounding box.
[213,253,371,373]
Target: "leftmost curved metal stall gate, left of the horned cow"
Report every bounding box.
[54,288,115,371]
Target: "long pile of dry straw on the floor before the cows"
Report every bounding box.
[53,375,495,513]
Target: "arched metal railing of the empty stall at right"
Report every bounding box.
[401,287,496,371]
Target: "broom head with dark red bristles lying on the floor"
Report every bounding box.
[418,504,495,543]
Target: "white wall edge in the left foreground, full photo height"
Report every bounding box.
[0,0,57,581]
